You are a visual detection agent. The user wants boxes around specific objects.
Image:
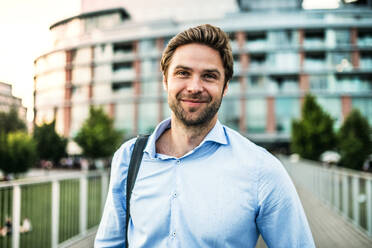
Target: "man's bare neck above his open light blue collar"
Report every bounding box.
[156,113,217,158]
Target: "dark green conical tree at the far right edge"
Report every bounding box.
[337,109,372,170]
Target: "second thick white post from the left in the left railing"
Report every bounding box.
[52,180,60,248]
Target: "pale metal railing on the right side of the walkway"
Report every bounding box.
[280,157,372,238]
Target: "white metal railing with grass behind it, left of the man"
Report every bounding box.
[0,171,108,248]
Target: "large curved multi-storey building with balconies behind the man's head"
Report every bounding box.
[34,0,372,149]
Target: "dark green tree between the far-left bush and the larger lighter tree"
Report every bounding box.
[33,121,67,164]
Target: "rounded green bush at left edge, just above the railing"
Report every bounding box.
[0,131,36,175]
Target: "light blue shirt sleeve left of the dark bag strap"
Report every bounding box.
[94,140,134,248]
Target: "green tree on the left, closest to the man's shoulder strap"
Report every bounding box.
[74,107,123,159]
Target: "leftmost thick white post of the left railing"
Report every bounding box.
[12,185,21,248]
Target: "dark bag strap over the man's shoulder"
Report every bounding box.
[125,135,149,248]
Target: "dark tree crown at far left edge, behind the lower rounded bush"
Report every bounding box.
[0,107,26,134]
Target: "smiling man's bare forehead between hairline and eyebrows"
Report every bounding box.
[169,43,224,73]
